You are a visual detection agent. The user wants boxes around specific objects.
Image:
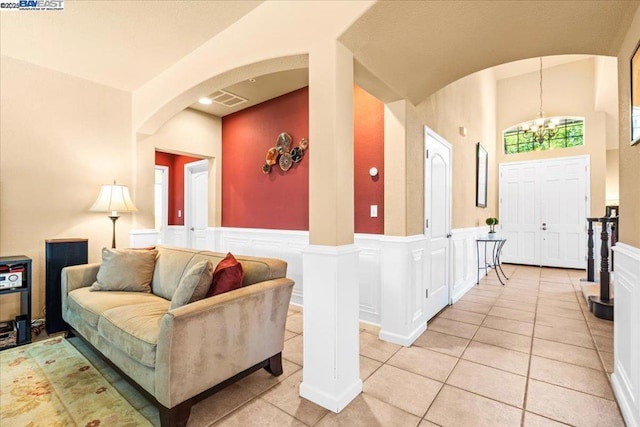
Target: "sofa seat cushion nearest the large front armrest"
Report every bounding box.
[98,298,169,367]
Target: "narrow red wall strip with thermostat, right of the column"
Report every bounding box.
[353,86,384,234]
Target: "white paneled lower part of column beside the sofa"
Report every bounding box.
[300,245,362,412]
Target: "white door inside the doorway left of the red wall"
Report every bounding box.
[184,160,209,249]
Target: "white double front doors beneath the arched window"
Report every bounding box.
[500,156,589,268]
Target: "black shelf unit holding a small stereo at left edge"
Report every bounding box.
[0,255,31,345]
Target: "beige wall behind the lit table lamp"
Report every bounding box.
[0,56,131,319]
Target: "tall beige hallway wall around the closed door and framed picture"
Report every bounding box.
[407,70,498,234]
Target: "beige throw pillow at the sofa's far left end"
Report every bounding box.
[91,248,158,292]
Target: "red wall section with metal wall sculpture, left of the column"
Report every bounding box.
[222,88,313,230]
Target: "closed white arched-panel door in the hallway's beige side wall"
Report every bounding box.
[424,126,451,320]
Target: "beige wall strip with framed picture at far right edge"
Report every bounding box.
[618,11,640,248]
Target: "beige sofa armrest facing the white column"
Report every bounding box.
[155,278,294,408]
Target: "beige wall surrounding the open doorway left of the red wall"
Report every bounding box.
[135,108,222,228]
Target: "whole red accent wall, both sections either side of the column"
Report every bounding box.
[222,86,384,234]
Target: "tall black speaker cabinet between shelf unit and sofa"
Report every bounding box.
[45,239,88,334]
